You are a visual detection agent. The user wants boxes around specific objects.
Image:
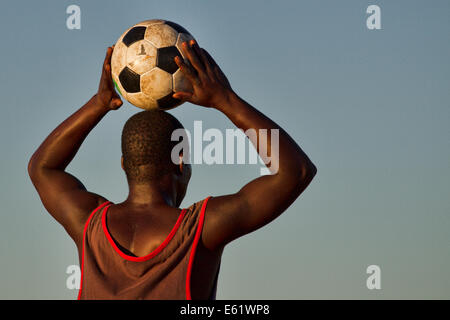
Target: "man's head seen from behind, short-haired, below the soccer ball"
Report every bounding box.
[122,110,191,204]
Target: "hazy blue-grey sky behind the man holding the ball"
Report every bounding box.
[0,0,450,299]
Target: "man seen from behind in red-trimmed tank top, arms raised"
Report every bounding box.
[28,40,316,299]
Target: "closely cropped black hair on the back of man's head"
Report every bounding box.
[122,110,184,183]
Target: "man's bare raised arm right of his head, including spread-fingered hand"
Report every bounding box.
[174,41,316,250]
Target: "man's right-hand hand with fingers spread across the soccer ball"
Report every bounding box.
[173,40,233,108]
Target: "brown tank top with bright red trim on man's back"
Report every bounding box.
[78,197,219,300]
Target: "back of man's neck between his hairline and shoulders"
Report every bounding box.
[125,178,177,207]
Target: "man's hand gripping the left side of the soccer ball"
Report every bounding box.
[95,46,123,110]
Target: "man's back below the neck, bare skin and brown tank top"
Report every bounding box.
[79,198,222,299]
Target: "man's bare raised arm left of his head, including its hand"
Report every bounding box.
[28,47,122,245]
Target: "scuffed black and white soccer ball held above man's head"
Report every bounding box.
[111,20,193,110]
